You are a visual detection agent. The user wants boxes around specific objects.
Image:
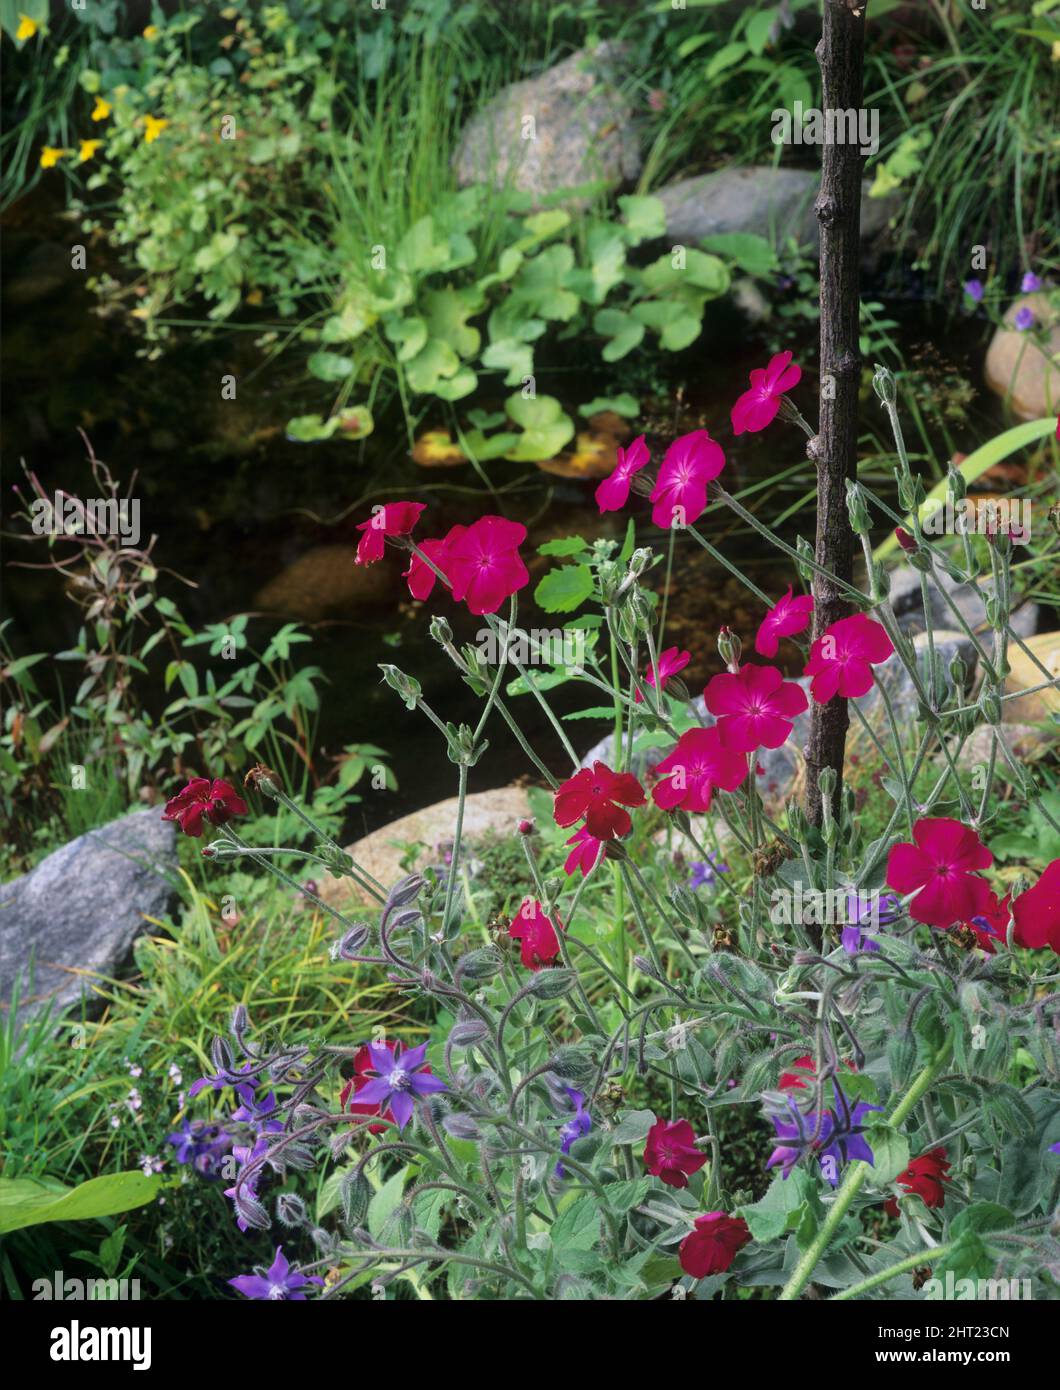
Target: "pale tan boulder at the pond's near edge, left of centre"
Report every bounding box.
[320,787,531,908]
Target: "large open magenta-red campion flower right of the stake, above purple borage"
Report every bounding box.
[886,816,993,929]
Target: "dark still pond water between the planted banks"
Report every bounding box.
[3,200,1022,837]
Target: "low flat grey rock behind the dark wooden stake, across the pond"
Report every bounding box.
[656,165,896,254]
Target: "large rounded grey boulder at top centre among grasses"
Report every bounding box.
[453,43,640,207]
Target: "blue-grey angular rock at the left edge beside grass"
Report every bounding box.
[0,806,176,1013]
